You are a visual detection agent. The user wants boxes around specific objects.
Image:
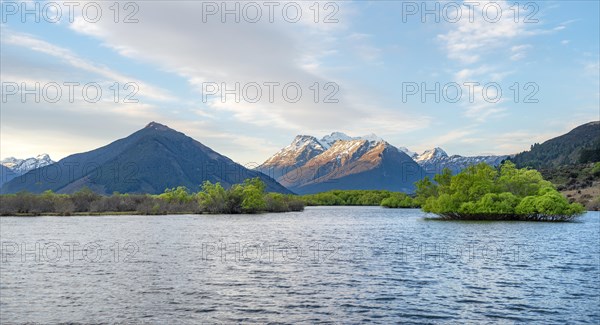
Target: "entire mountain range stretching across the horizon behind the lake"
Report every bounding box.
[0,121,600,194]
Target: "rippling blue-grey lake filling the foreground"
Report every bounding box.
[0,207,600,324]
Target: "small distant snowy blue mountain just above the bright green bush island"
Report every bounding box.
[413,147,508,174]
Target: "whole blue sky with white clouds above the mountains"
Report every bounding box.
[0,1,600,164]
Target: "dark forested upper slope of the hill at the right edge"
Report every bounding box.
[511,121,600,168]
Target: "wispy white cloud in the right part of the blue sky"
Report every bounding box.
[438,1,547,122]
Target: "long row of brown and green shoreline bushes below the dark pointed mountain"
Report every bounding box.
[0,178,304,216]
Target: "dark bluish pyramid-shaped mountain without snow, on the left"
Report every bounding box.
[2,122,290,194]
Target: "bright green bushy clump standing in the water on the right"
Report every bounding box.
[415,161,585,221]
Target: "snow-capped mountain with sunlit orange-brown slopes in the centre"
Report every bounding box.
[257,132,424,194]
